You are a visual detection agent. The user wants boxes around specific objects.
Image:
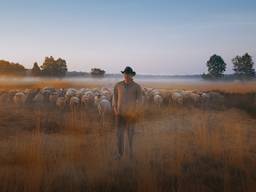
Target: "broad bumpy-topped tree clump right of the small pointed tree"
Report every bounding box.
[41,56,67,77]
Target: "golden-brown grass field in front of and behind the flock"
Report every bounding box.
[0,80,256,192]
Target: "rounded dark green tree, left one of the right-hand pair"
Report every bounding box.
[203,55,227,79]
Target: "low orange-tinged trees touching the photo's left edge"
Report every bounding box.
[0,60,27,75]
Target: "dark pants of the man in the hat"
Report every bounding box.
[116,115,135,158]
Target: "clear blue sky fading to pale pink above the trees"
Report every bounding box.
[0,0,256,75]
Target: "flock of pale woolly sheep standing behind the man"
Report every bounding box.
[0,87,228,114]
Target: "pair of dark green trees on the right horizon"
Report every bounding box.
[202,53,255,80]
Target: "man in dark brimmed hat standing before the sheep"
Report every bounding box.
[112,66,142,159]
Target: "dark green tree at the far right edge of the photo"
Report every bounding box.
[232,53,255,79]
